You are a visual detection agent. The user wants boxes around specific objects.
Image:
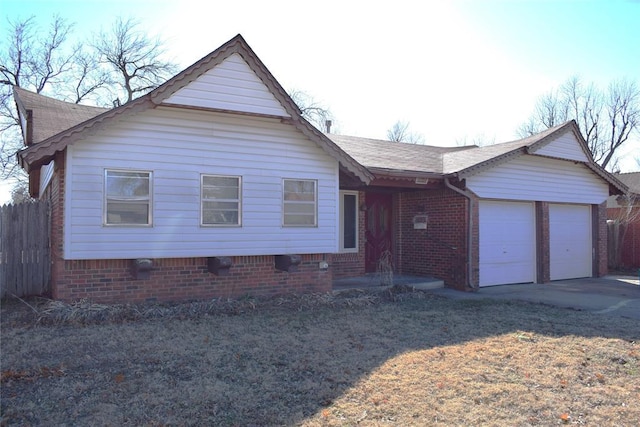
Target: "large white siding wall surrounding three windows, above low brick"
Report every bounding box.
[64,107,338,259]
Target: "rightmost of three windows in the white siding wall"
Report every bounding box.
[282,179,318,227]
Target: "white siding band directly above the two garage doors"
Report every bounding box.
[467,155,609,204]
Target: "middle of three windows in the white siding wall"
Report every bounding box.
[200,175,242,226]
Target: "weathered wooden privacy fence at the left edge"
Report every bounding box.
[0,201,51,298]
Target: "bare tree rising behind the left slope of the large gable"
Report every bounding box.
[94,18,177,102]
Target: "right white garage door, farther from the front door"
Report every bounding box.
[549,204,593,280]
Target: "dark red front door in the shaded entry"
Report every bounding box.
[365,193,391,273]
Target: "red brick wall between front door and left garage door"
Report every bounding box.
[395,189,468,289]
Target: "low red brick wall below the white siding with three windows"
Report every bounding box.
[55,254,331,303]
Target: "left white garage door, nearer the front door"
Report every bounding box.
[479,200,536,286]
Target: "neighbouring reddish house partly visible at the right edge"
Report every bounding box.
[607,172,640,270]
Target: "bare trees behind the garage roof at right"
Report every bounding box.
[518,77,640,169]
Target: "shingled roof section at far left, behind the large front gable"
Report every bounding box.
[13,87,108,143]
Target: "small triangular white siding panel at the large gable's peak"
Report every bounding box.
[163,53,289,117]
